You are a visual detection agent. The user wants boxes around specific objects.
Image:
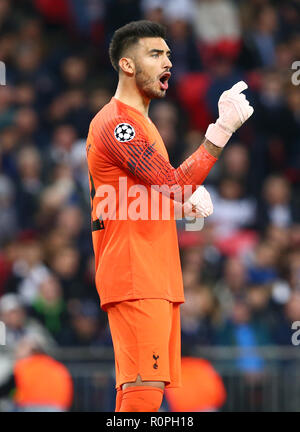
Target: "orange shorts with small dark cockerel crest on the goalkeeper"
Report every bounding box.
[107,299,181,388]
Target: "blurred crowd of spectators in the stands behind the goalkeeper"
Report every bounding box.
[0,0,300,411]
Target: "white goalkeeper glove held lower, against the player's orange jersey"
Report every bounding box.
[183,186,214,218]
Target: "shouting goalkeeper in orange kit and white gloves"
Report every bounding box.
[87,21,253,412]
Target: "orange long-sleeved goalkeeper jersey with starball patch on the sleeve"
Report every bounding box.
[87,97,216,309]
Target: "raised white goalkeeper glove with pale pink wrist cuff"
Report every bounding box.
[205,81,254,147]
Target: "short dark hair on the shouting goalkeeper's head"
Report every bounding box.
[109,20,166,71]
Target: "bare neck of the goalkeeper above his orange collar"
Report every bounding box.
[114,78,150,117]
